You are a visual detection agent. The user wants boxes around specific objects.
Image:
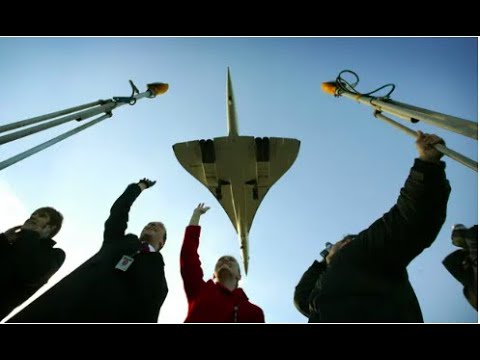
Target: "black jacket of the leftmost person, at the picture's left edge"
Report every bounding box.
[0,231,65,320]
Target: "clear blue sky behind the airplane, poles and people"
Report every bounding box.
[0,38,478,323]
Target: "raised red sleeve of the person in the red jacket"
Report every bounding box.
[180,225,205,301]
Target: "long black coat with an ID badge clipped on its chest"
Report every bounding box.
[9,184,168,323]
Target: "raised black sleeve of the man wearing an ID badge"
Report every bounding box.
[103,184,142,243]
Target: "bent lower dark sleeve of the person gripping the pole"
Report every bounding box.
[293,260,327,318]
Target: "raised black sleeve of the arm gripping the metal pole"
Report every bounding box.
[358,159,450,267]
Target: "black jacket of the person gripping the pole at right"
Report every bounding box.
[294,159,450,322]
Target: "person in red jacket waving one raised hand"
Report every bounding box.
[180,203,265,323]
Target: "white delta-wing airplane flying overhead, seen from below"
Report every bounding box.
[173,68,300,273]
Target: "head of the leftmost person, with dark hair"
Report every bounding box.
[22,207,63,238]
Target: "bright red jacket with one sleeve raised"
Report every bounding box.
[180,225,265,323]
